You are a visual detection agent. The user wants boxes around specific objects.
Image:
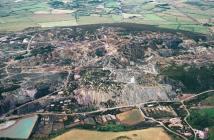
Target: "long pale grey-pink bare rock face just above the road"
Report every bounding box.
[75,84,176,106]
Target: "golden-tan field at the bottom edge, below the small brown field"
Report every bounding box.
[54,128,171,140]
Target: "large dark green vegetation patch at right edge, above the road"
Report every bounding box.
[161,65,214,92]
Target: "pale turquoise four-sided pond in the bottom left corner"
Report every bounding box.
[0,115,38,139]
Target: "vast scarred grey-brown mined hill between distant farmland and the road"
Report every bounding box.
[0,26,214,115]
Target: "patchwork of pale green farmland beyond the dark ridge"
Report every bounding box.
[0,0,214,34]
